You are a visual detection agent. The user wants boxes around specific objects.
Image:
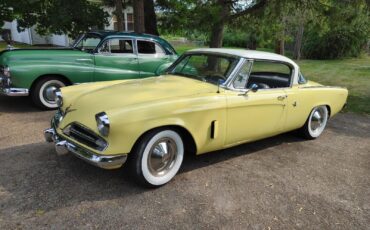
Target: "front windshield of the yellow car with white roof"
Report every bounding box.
[168,54,239,85]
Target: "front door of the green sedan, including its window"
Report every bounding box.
[94,38,140,81]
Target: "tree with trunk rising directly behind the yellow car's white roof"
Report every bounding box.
[157,0,268,47]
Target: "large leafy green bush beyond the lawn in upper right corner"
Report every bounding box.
[303,2,370,59]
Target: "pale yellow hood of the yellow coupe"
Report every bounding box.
[62,75,217,118]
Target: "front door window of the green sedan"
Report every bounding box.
[99,38,134,54]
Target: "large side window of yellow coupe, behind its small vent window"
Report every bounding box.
[247,60,292,89]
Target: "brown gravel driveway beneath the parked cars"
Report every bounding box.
[0,97,370,229]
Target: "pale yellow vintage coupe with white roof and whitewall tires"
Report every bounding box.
[44,49,348,186]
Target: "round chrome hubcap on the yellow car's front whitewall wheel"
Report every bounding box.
[148,138,177,176]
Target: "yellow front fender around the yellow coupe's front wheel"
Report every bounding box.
[106,94,226,154]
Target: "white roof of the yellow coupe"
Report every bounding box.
[190,48,297,68]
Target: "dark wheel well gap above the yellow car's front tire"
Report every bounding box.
[132,125,197,154]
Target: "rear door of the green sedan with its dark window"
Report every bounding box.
[136,39,176,77]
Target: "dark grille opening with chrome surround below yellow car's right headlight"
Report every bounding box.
[63,123,108,151]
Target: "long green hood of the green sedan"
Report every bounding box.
[0,48,91,65]
